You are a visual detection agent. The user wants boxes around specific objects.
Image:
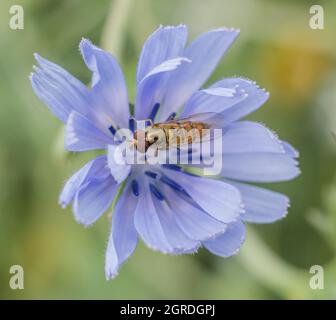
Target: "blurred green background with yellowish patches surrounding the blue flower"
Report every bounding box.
[0,0,336,299]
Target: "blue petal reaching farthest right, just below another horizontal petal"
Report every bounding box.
[221,152,300,182]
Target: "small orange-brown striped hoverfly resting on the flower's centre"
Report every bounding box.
[133,112,223,153]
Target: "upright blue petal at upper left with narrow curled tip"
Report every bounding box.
[80,39,130,128]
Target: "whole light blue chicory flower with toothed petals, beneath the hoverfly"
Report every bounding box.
[31,25,299,279]
